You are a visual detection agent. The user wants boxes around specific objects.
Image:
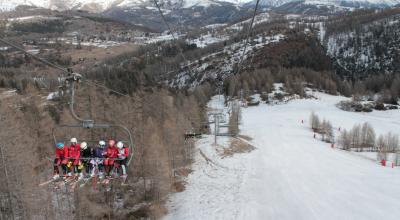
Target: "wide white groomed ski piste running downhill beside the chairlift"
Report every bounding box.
[164,90,400,220]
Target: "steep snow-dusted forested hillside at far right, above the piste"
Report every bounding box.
[325,14,400,77]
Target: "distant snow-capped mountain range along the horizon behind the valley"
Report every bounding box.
[0,0,400,31]
